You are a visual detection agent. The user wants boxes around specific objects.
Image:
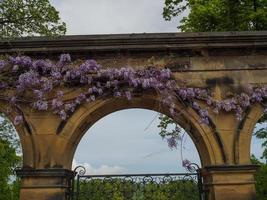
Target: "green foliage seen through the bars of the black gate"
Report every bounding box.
[76,179,198,200]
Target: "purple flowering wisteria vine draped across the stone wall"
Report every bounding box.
[0,54,267,146]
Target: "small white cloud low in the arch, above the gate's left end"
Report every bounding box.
[72,159,125,175]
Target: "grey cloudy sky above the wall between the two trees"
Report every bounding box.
[52,0,179,35]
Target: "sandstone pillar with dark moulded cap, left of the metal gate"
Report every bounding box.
[16,169,74,200]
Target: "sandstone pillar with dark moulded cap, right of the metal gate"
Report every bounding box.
[203,165,258,200]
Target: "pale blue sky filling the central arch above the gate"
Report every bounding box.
[72,108,201,175]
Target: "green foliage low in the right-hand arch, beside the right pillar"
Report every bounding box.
[251,155,267,200]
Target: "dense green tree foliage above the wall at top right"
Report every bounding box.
[163,0,267,32]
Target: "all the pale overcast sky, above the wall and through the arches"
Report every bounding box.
[48,0,262,174]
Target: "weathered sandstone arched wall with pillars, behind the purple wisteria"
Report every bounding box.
[0,32,267,200]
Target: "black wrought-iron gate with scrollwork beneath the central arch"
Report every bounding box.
[69,164,205,200]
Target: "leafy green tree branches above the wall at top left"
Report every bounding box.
[0,0,66,37]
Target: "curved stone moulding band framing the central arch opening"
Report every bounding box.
[61,94,225,169]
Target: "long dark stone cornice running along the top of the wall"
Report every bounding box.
[0,31,267,55]
